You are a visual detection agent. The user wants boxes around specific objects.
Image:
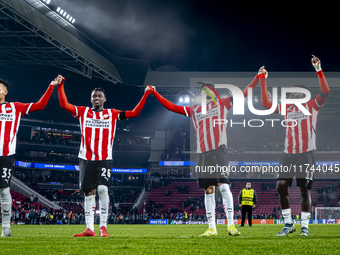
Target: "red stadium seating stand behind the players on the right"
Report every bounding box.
[139,179,340,219]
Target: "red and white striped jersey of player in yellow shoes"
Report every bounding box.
[184,97,232,153]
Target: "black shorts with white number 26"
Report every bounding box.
[79,159,112,192]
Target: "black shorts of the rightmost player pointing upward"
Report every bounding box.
[277,150,316,189]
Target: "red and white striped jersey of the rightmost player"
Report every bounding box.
[276,96,326,154]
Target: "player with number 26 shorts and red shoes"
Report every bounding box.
[58,76,153,237]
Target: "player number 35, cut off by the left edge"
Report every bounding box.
[0,77,61,237]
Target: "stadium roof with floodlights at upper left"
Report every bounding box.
[0,0,122,84]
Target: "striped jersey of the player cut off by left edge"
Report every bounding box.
[0,102,33,156]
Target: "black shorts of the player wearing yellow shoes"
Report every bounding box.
[196,145,229,189]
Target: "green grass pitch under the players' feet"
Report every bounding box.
[0,224,340,255]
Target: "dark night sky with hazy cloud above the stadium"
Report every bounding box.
[52,0,340,71]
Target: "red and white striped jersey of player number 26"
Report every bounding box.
[74,106,121,161]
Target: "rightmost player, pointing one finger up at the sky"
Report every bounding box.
[260,55,330,236]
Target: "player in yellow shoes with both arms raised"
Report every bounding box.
[153,69,261,237]
